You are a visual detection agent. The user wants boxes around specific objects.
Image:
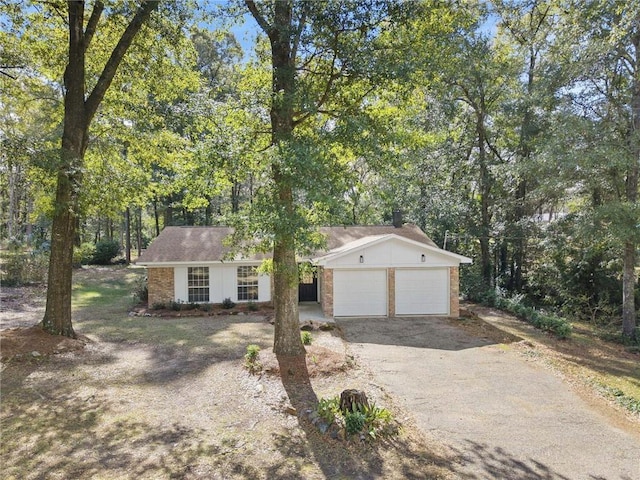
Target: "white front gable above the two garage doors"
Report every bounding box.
[312,234,471,268]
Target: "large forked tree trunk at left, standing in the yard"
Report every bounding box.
[41,0,158,337]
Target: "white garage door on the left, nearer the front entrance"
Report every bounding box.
[333,270,387,317]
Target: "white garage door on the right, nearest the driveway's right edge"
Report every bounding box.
[396,268,449,315]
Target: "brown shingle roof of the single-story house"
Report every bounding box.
[136,224,437,265]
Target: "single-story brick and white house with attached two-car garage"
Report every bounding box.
[136,218,471,317]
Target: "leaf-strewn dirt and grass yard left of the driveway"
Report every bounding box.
[0,269,456,479]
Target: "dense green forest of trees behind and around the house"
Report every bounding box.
[0,0,640,339]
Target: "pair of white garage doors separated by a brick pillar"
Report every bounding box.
[333,268,449,317]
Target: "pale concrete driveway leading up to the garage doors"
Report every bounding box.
[338,318,640,480]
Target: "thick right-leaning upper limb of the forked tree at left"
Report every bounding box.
[85,0,160,123]
